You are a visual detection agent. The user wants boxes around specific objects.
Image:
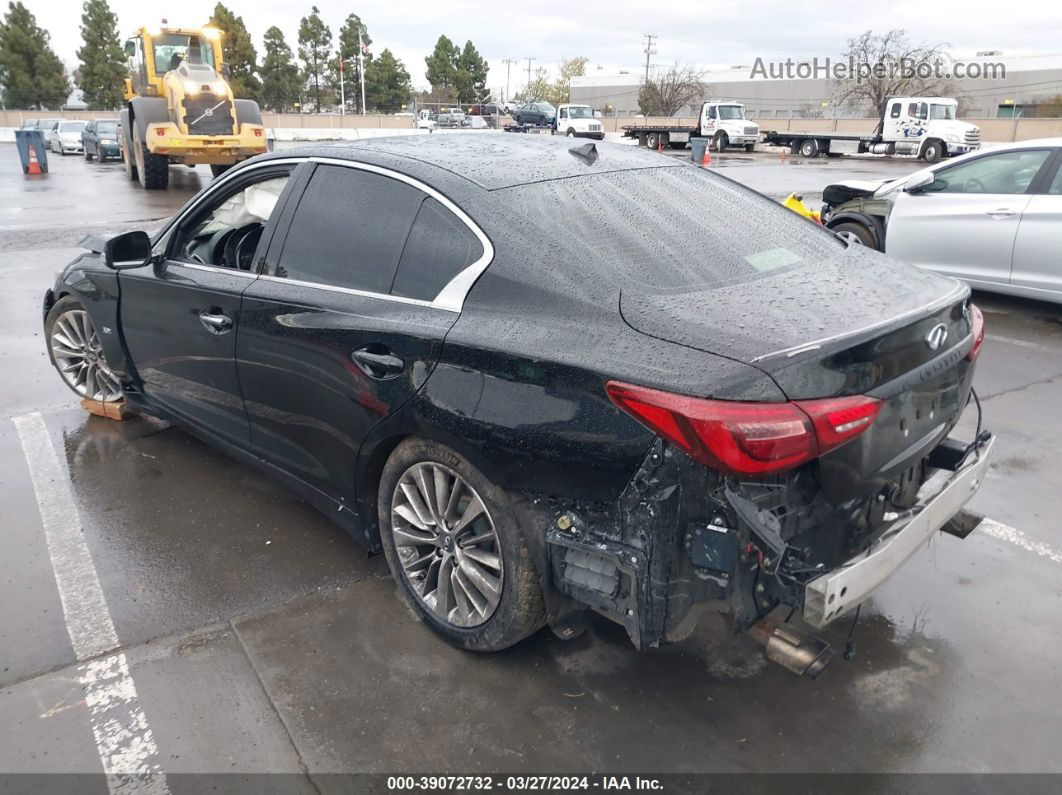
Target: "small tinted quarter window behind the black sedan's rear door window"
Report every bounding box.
[391,196,483,300]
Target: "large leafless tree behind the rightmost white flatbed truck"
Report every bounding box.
[834,30,949,116]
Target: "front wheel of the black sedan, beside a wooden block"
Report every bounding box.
[45,296,122,402]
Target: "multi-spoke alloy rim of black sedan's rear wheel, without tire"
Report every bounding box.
[391,462,504,627]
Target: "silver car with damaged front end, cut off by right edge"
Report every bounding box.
[822,138,1062,303]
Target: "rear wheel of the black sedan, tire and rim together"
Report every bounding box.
[377,438,546,652]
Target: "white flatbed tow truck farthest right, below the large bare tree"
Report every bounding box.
[764,97,981,162]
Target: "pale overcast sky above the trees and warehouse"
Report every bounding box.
[22,0,1062,92]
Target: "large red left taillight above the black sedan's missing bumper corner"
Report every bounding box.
[605,381,881,476]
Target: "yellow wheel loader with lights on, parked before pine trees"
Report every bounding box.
[119,28,267,189]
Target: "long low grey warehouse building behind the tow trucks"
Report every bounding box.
[571,51,1062,119]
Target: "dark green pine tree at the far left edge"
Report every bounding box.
[0,2,70,109]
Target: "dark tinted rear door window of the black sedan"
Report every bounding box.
[274,166,424,294]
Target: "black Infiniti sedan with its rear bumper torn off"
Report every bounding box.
[44,136,992,664]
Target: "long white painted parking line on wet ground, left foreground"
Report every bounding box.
[12,412,170,795]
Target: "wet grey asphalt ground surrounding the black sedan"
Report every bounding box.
[0,137,1062,792]
